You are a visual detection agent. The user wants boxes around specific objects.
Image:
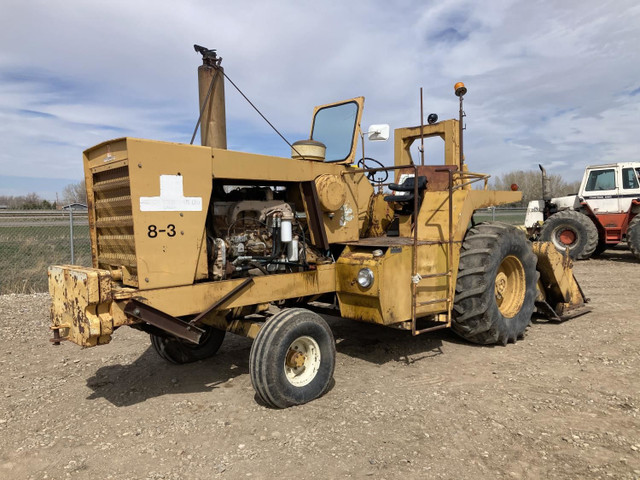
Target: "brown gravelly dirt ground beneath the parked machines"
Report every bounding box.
[0,250,640,479]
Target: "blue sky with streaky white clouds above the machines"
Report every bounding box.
[0,0,640,199]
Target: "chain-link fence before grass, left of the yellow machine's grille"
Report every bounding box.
[0,209,91,295]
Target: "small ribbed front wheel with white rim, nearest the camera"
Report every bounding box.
[249,308,336,408]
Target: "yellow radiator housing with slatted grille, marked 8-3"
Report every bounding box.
[84,138,212,290]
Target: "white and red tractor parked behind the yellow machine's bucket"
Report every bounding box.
[525,162,640,260]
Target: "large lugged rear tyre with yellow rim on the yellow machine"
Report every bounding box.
[451,223,538,345]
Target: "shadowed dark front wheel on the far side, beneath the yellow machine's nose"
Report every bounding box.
[151,326,227,364]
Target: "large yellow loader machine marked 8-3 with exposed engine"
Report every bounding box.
[49,47,587,408]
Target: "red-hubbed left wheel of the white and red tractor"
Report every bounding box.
[540,210,598,260]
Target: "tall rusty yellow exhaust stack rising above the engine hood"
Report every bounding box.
[193,45,227,149]
